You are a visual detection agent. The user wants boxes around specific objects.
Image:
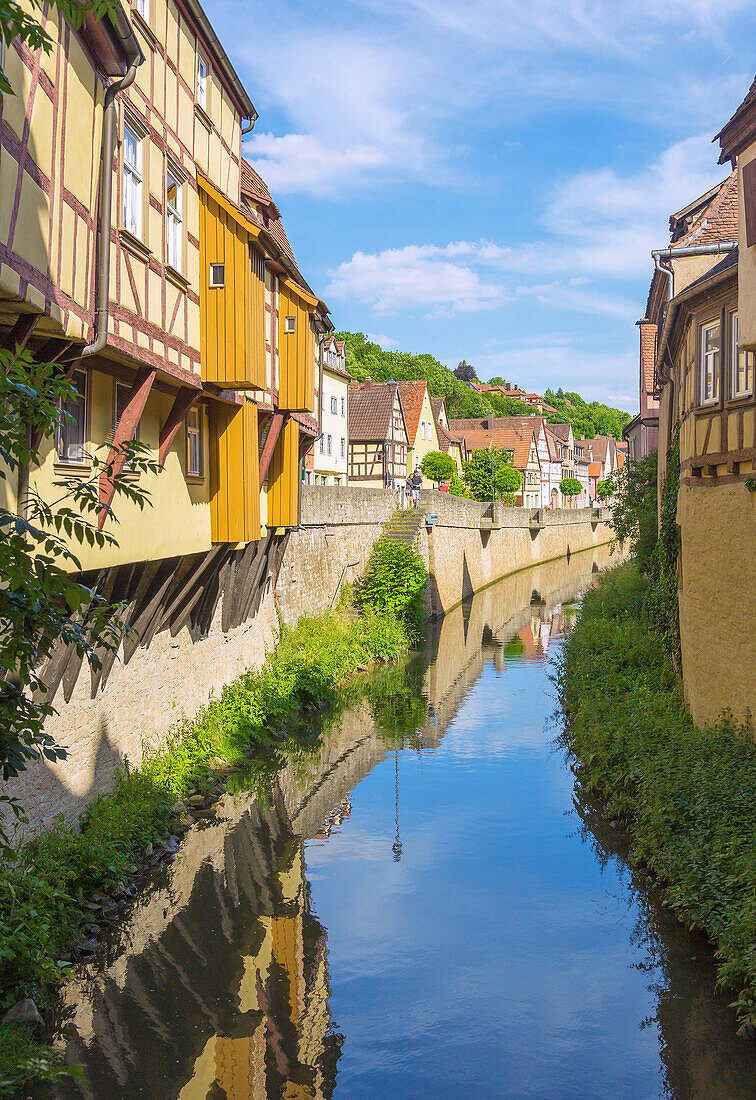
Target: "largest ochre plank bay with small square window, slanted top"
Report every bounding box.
[199,187,266,389]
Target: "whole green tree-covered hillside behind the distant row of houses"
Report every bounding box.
[336,332,631,439]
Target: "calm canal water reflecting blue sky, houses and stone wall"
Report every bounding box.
[45,550,756,1100]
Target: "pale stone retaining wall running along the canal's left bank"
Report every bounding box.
[7,485,612,833]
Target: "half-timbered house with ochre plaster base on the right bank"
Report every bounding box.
[644,118,756,722]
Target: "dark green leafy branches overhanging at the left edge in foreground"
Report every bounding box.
[0,348,157,792]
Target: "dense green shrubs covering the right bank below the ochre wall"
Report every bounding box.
[559,562,756,1029]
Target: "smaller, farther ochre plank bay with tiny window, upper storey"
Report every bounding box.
[278,279,317,414]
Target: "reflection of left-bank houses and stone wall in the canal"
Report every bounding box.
[51,548,625,1100]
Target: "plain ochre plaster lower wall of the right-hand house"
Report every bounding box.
[678,483,756,723]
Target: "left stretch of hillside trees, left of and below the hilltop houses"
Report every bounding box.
[336,332,534,419]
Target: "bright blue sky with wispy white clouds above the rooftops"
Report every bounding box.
[206,0,756,410]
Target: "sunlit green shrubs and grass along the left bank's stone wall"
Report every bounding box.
[0,611,410,1095]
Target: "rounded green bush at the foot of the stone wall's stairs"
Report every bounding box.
[358,537,428,638]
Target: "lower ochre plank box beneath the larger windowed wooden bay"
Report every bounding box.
[210,400,260,542]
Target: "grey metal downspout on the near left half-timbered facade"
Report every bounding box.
[81,15,144,359]
